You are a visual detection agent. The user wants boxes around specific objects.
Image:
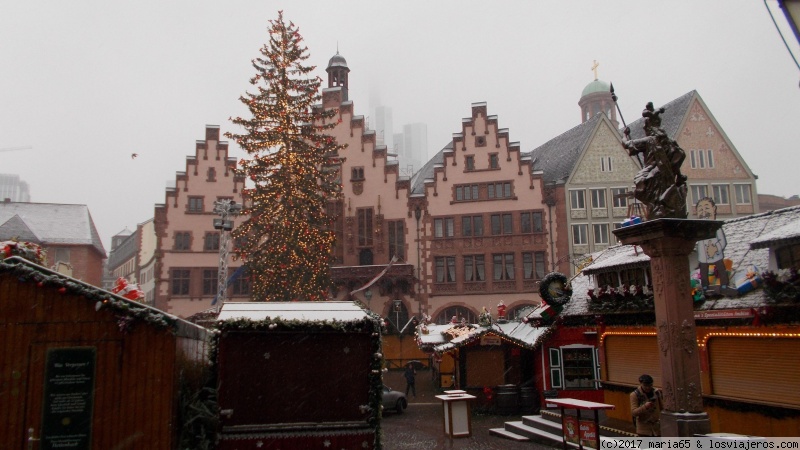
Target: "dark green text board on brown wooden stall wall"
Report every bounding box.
[41,347,97,450]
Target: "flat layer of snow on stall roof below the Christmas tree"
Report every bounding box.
[217,302,368,322]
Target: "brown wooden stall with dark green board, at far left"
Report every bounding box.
[0,257,209,449]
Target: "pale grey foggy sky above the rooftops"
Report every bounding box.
[0,0,800,250]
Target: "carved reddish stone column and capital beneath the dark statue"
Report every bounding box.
[614,219,722,437]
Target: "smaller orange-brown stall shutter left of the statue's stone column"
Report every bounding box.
[605,335,661,386]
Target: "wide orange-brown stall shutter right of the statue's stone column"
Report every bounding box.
[707,337,800,406]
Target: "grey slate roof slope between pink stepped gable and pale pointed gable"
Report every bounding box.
[528,114,605,184]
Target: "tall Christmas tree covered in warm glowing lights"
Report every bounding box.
[226,11,342,301]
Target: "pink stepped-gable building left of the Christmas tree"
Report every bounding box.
[153,125,250,317]
